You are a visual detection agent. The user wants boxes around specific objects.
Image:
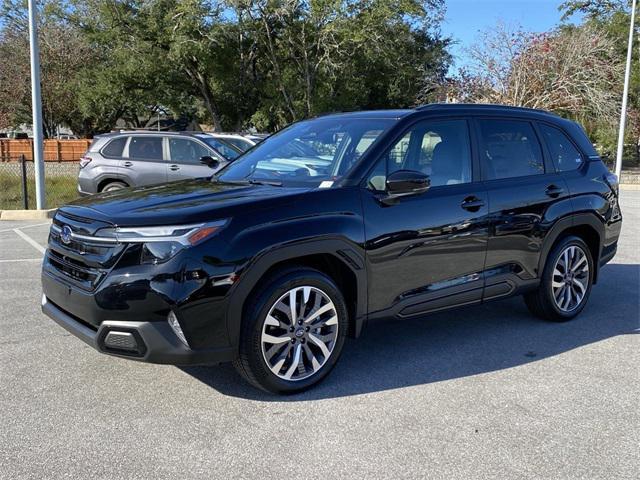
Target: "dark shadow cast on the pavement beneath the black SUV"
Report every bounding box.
[183,264,640,401]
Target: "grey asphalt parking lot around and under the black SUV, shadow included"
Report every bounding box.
[0,191,640,479]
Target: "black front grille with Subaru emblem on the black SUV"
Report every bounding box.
[45,213,126,291]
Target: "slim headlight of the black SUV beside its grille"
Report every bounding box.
[97,220,227,264]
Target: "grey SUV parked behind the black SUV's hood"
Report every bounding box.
[78,131,240,195]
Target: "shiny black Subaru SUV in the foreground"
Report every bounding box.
[42,105,621,392]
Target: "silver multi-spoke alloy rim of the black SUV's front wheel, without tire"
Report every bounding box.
[260,286,339,381]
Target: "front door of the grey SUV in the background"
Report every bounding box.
[167,137,219,182]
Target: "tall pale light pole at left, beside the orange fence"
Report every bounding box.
[29,0,45,210]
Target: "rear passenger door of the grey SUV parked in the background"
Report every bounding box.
[121,135,167,186]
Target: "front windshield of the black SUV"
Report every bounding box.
[218,117,396,187]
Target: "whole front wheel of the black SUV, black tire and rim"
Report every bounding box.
[234,267,348,394]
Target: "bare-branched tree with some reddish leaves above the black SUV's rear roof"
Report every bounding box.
[442,25,623,129]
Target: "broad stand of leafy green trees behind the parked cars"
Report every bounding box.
[0,0,450,133]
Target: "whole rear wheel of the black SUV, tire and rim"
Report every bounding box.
[524,236,594,322]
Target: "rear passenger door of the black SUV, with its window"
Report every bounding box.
[475,117,568,299]
